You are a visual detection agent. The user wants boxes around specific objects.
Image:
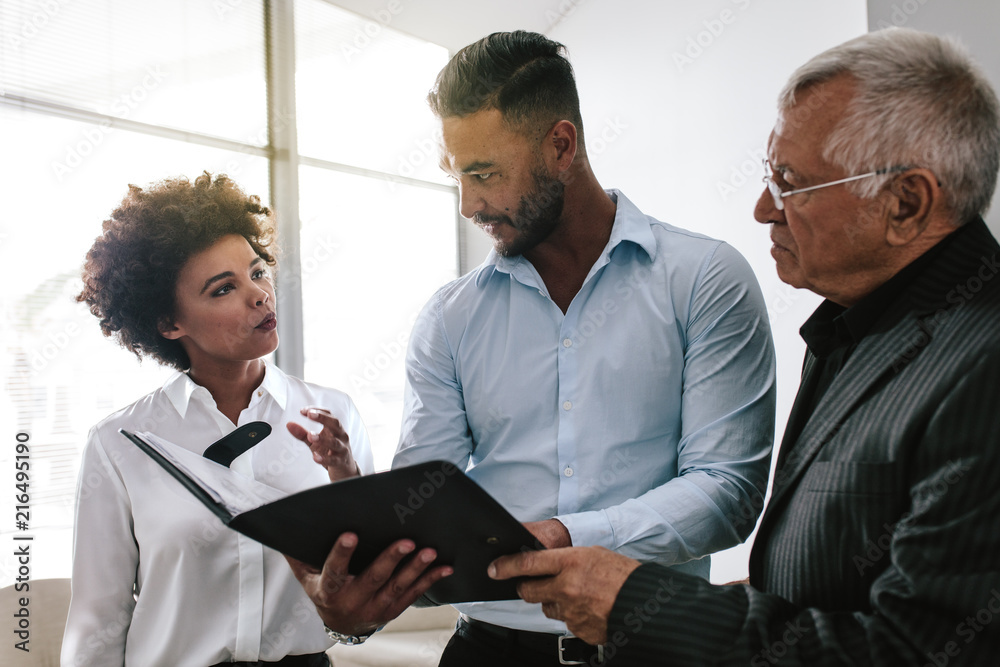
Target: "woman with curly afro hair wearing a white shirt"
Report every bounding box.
[62,173,373,667]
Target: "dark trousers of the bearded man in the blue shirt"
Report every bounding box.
[438,618,606,667]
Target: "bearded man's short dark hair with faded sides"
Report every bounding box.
[427,30,584,149]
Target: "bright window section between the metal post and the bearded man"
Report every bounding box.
[295,0,458,468]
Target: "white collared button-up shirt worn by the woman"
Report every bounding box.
[62,365,374,667]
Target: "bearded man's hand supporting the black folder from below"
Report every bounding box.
[285,533,452,635]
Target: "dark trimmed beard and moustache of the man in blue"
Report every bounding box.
[473,168,566,257]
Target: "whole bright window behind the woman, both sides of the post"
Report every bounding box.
[0,0,458,586]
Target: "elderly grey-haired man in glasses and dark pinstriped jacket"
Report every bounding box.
[490,29,1000,667]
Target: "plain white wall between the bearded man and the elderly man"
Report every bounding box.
[550,0,867,581]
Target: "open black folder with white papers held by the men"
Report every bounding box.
[121,423,543,604]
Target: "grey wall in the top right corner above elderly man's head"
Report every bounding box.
[868,0,1000,236]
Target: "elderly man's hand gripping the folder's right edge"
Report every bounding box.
[489,547,639,645]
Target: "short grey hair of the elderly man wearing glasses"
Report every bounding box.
[778,28,1000,224]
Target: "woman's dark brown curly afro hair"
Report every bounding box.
[76,172,276,371]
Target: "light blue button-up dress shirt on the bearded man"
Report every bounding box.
[393,190,775,632]
